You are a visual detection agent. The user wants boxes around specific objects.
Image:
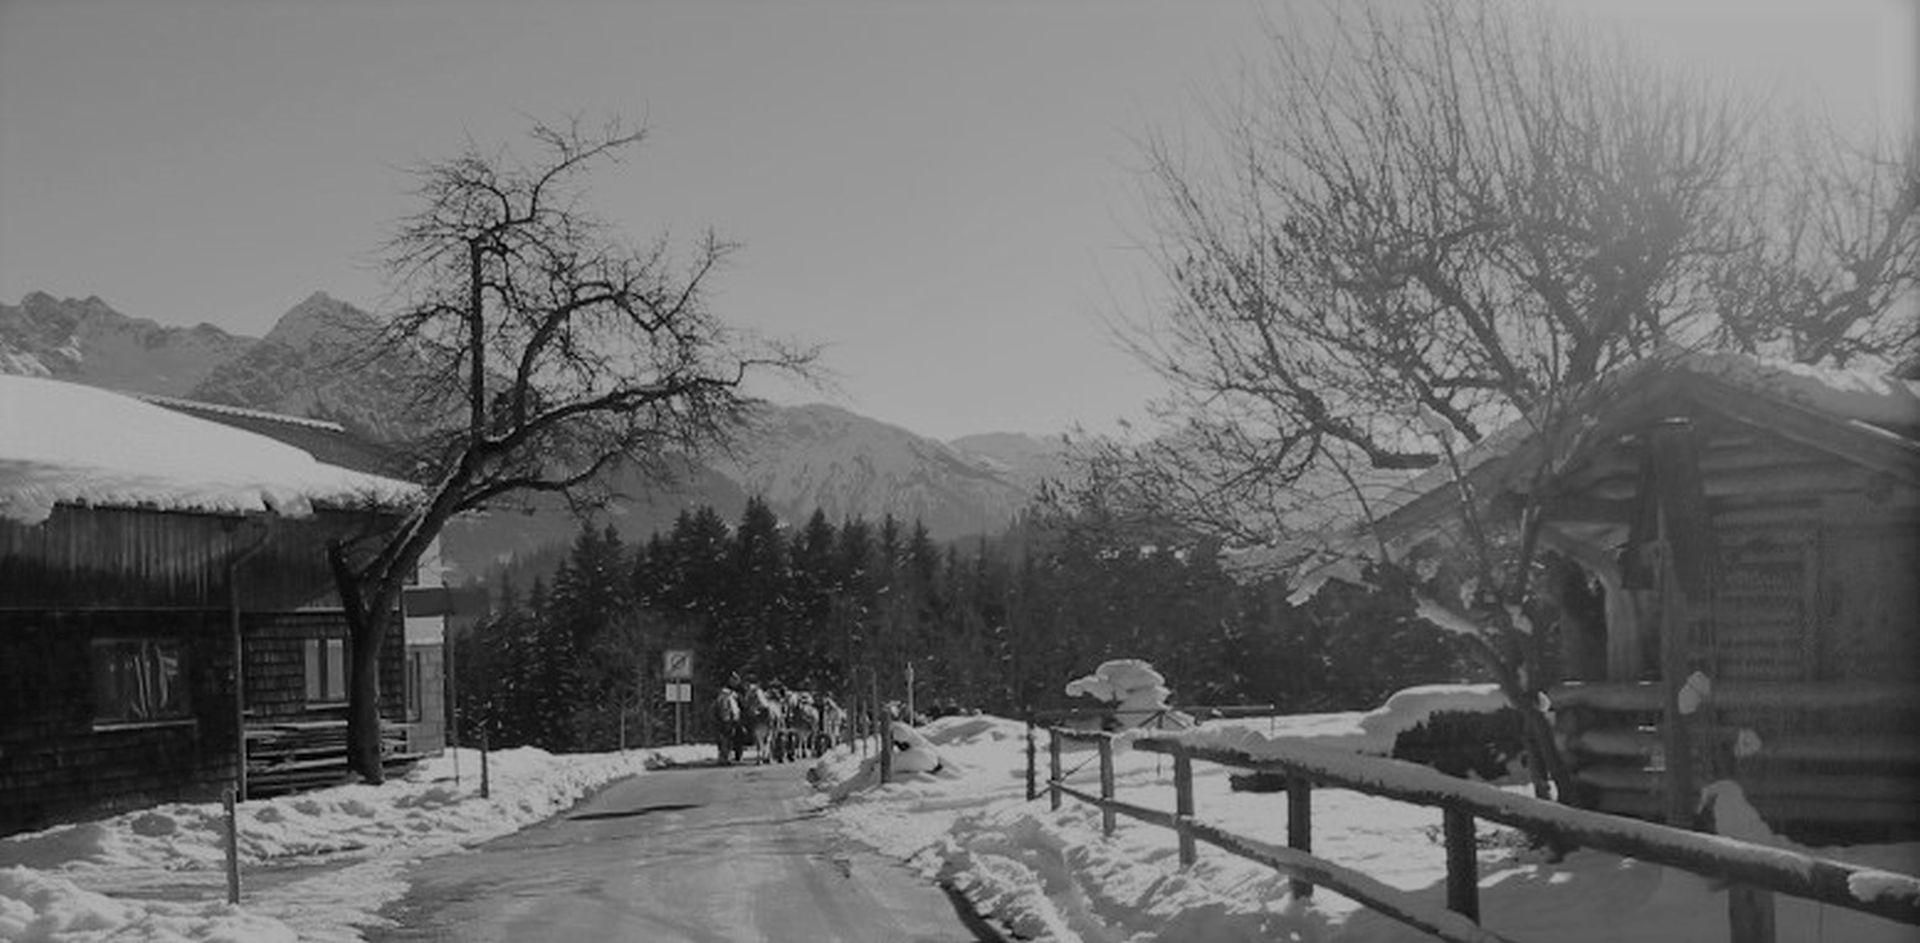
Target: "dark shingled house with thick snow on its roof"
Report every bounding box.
[0,376,413,834]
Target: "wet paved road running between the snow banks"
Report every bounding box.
[369,764,996,943]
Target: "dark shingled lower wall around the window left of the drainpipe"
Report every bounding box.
[0,609,236,834]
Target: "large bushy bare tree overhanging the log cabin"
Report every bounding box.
[1092,0,1920,795]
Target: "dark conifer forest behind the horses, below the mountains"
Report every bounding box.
[455,499,1471,751]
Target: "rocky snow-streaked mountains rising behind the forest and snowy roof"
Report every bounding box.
[0,292,1066,576]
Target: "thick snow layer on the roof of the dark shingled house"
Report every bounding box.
[0,375,417,524]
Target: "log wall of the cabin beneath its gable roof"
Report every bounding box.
[1555,419,1920,837]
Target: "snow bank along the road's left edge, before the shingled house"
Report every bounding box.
[0,747,712,943]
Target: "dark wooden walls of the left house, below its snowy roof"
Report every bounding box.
[0,507,420,834]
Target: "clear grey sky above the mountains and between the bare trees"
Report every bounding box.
[0,0,1920,438]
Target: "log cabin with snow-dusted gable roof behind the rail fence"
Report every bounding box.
[1379,353,1920,835]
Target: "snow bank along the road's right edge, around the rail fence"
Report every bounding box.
[814,714,1920,943]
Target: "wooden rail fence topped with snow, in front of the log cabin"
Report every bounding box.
[1027,728,1920,943]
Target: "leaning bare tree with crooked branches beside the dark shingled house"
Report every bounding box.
[328,121,814,782]
